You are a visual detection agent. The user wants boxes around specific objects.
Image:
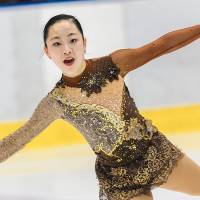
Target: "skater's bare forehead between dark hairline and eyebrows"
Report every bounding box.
[48,20,80,39]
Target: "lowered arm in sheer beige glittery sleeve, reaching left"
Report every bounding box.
[0,91,60,162]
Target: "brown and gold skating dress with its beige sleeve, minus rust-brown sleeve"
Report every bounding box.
[0,55,184,200]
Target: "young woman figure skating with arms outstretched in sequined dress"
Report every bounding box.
[0,14,200,200]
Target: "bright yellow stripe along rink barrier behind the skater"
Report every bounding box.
[0,104,200,149]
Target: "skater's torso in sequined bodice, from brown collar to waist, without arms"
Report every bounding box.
[50,56,156,164]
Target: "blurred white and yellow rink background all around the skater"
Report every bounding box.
[0,0,200,200]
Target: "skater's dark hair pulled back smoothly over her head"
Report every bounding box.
[43,14,84,47]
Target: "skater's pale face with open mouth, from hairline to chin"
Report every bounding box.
[44,20,86,77]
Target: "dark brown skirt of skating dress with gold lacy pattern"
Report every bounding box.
[95,131,184,200]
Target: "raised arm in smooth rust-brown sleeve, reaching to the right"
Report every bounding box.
[110,25,200,76]
